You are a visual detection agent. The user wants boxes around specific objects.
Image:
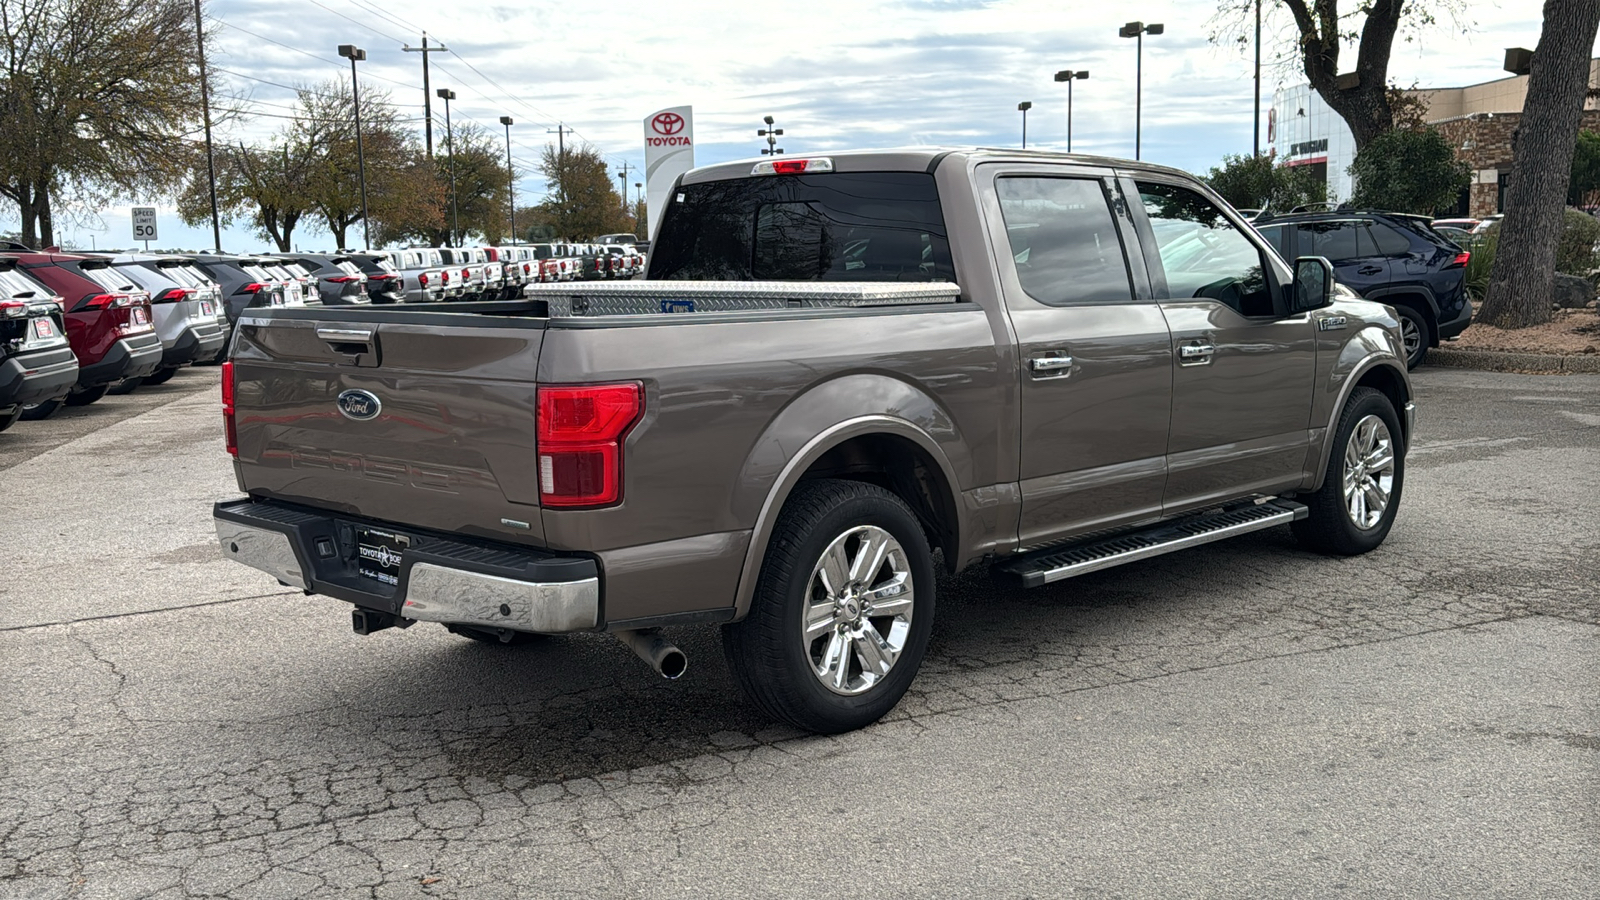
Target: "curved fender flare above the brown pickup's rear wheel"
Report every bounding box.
[734,373,973,620]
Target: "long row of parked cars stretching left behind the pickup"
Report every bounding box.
[0,243,645,431]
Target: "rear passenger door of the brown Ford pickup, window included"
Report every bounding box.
[984,167,1173,549]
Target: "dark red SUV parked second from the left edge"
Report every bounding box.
[0,251,162,420]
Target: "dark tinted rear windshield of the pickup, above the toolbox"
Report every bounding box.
[651,171,955,282]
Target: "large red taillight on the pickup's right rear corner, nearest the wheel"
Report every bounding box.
[538,381,645,508]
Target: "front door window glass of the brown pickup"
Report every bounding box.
[1139,181,1273,315]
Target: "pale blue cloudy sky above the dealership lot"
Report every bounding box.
[25,0,1561,250]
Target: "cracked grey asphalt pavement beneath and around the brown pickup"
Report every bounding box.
[0,360,1600,900]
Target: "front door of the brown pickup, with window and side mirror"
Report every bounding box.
[1134,178,1317,516]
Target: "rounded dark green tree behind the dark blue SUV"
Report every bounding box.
[1350,128,1472,215]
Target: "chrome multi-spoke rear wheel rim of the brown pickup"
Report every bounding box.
[800,525,915,695]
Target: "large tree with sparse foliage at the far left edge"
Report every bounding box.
[0,0,214,245]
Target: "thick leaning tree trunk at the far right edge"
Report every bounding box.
[1478,0,1600,328]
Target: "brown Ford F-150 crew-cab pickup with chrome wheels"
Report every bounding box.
[214,151,1414,732]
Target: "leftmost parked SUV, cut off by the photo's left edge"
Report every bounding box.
[0,259,78,431]
